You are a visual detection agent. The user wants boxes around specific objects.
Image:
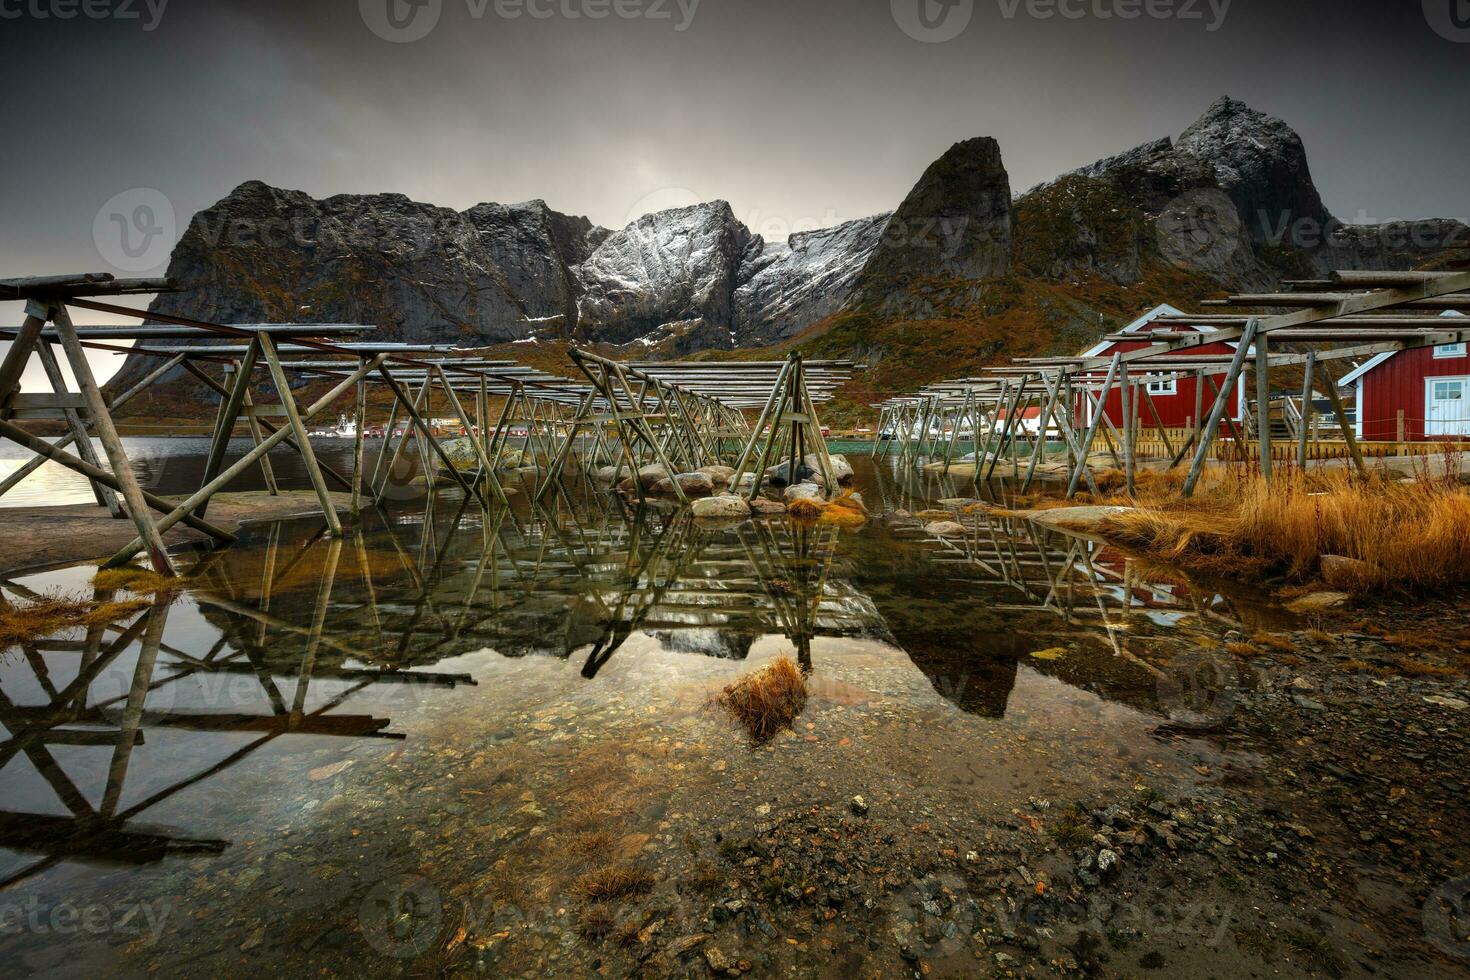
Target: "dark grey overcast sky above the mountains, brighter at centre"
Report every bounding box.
[0,0,1470,302]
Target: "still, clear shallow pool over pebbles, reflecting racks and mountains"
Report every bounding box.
[0,449,1274,976]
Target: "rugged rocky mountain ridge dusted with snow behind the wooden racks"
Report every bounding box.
[115,97,1467,417]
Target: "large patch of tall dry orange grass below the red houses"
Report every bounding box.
[1108,472,1470,592]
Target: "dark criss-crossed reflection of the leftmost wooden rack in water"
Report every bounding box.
[0,549,473,887]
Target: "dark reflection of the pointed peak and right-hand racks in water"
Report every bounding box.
[853,485,1250,717]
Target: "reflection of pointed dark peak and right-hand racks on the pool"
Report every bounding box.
[854,460,1283,720]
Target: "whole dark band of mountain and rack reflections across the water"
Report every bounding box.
[0,467,1258,910]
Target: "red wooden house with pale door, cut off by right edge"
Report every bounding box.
[1338,310,1470,442]
